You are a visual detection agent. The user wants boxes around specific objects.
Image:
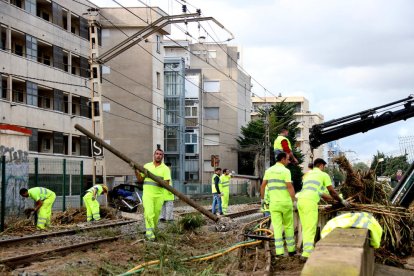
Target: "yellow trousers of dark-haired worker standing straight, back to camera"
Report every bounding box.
[269,199,296,255]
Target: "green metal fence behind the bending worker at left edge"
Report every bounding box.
[0,156,84,231]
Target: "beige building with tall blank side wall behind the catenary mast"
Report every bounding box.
[99,8,170,184]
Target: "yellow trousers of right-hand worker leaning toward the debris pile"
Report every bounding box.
[297,198,318,257]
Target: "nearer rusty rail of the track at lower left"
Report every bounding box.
[0,235,125,269]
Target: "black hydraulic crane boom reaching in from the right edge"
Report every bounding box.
[309,95,414,149]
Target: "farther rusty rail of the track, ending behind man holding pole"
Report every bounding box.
[0,220,137,247]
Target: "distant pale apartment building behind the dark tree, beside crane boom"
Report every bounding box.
[251,96,324,168]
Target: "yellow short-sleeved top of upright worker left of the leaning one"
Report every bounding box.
[263,162,292,202]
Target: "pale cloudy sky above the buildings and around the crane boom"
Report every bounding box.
[92,0,414,162]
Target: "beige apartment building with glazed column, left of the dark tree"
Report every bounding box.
[164,41,251,183]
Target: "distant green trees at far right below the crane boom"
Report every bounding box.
[371,152,410,180]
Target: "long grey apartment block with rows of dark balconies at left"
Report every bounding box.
[0,0,98,175]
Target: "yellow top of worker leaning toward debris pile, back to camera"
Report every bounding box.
[296,168,332,203]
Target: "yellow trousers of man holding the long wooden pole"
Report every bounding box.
[142,192,164,240]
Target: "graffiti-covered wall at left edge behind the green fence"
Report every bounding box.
[0,145,29,215]
